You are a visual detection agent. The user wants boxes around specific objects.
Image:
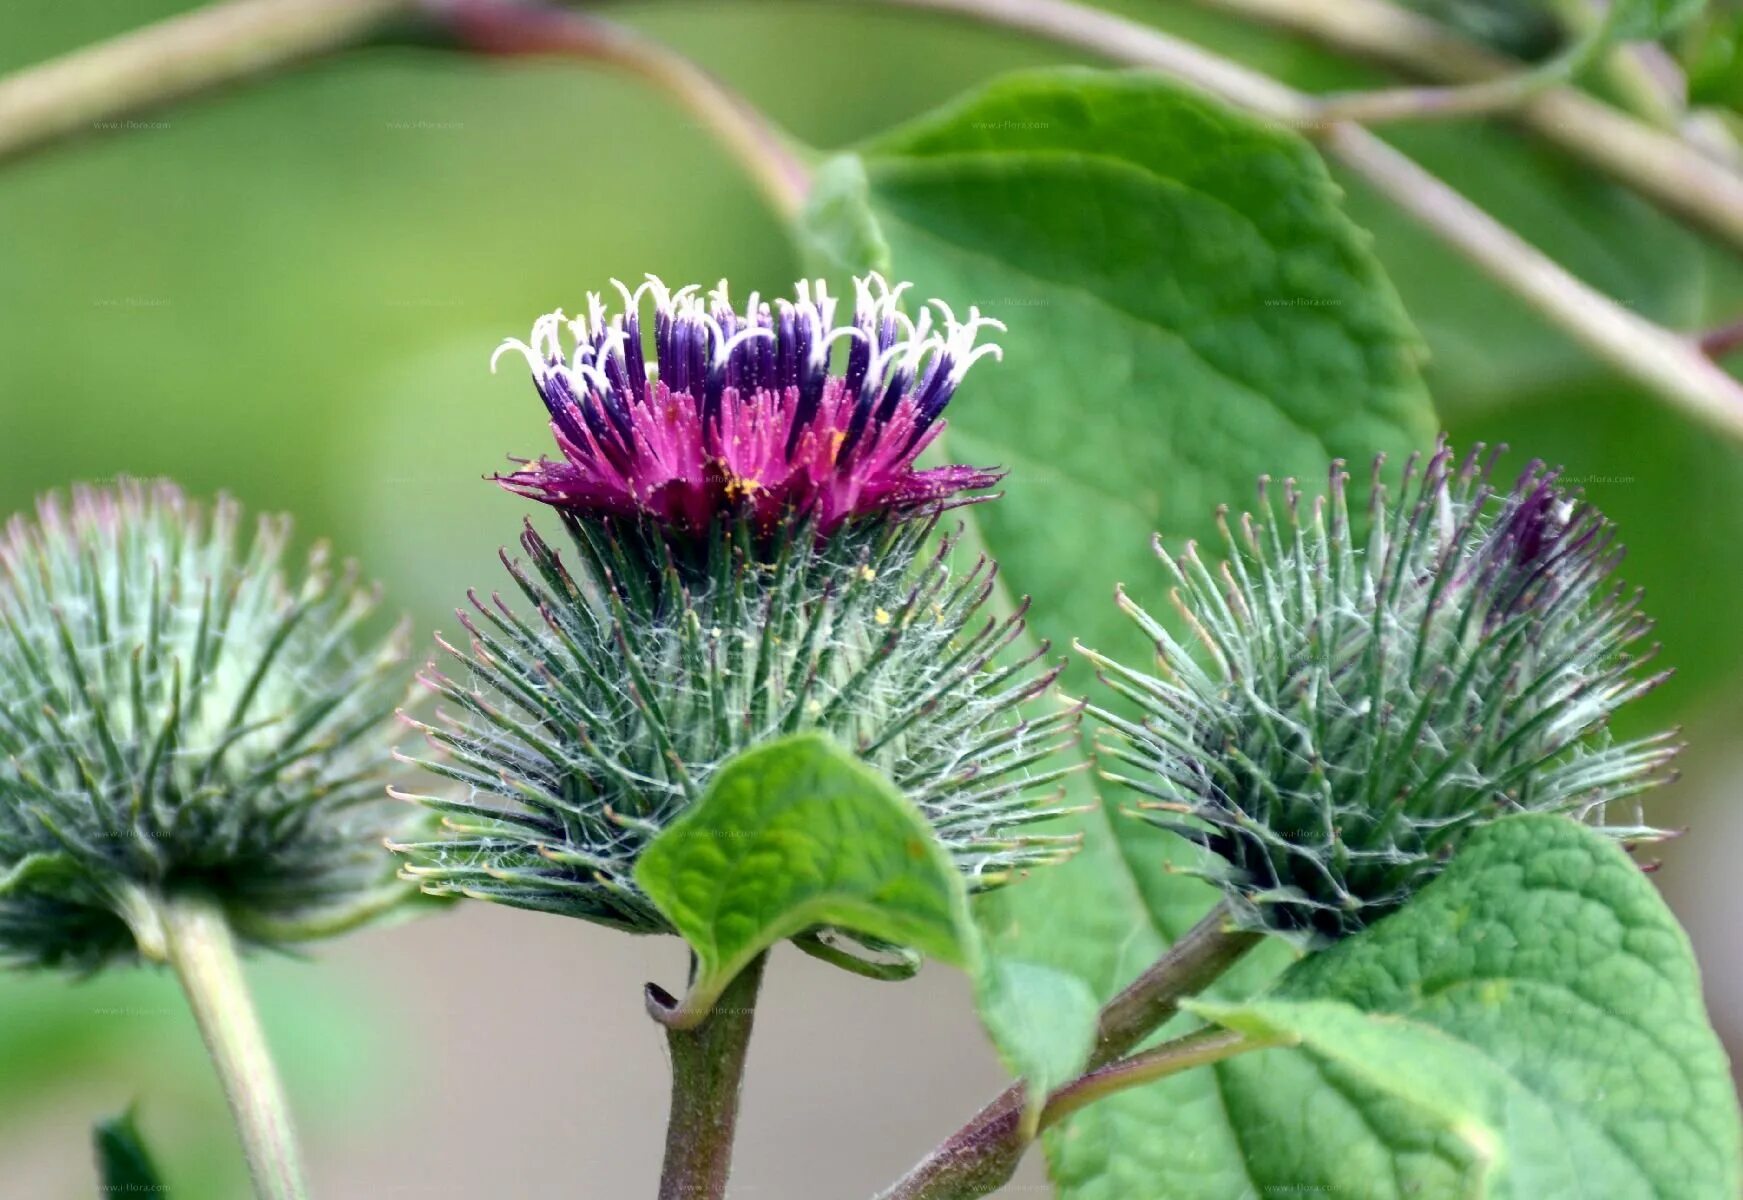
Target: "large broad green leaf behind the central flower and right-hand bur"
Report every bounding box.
[800,72,1434,1200]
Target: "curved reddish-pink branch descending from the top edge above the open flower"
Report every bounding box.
[424,0,810,218]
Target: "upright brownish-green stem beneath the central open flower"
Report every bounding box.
[648,954,767,1200]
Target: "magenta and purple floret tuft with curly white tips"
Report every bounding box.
[492,274,1004,535]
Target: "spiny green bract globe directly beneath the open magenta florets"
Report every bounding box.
[396,513,1077,933]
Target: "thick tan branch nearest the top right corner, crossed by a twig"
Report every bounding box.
[1197,0,1743,249]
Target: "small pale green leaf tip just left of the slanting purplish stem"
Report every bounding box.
[974,958,1102,1135]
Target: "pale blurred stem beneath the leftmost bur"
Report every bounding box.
[157,893,309,1200]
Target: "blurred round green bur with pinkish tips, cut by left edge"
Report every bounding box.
[0,481,404,970]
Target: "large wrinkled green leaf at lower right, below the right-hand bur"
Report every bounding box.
[1192,815,1743,1200]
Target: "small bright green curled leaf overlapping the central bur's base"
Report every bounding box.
[636,734,976,1026]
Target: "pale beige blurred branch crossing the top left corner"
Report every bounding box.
[0,0,415,162]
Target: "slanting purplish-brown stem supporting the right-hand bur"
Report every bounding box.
[882,903,1262,1200]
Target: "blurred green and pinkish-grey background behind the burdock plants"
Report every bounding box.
[0,0,1743,1200]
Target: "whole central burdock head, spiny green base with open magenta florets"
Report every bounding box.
[397,277,1077,931]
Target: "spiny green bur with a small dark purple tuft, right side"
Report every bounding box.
[1089,445,1677,942]
